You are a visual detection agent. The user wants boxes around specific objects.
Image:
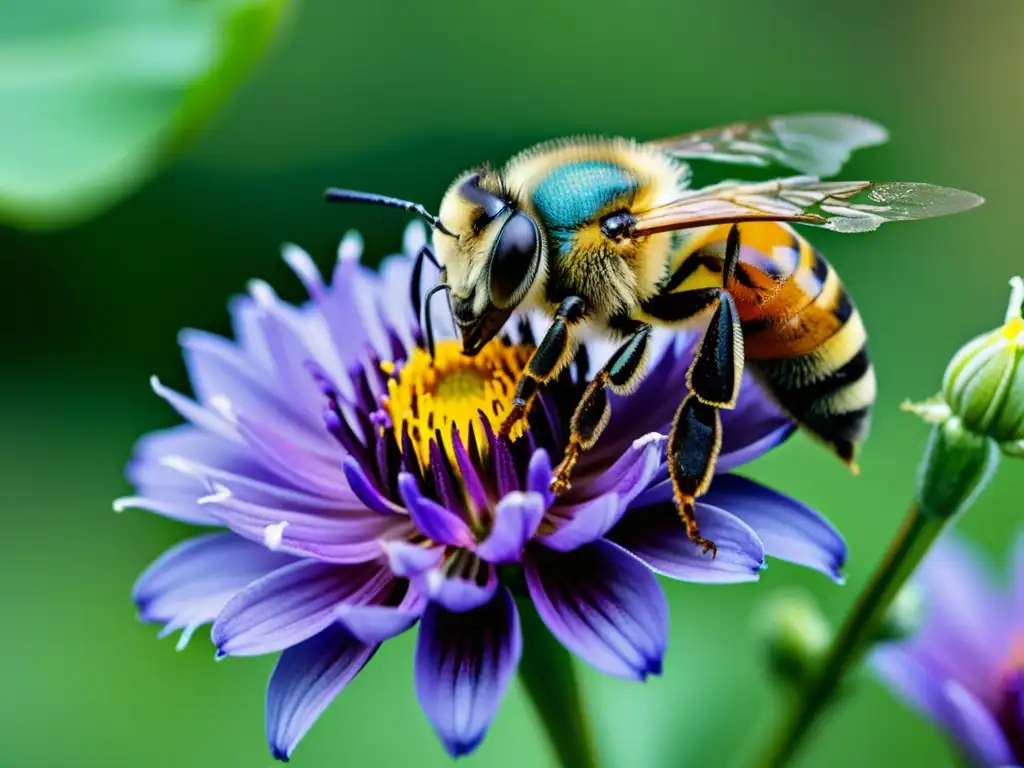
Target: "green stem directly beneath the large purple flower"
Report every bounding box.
[519,600,599,768]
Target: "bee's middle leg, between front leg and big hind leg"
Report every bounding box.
[551,324,651,494]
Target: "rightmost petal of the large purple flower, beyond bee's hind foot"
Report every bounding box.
[701,475,846,582]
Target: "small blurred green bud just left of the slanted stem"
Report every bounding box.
[759,593,833,688]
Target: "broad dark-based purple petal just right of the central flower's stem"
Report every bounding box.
[525,541,669,680]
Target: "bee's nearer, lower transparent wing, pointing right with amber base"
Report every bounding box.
[634,176,984,234]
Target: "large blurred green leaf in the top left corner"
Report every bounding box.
[0,0,289,228]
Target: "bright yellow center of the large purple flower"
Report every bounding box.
[381,339,534,467]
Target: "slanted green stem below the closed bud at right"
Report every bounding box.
[763,502,947,768]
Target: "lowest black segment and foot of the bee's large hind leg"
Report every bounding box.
[668,394,722,557]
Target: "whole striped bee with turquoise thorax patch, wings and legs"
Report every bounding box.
[327,114,983,556]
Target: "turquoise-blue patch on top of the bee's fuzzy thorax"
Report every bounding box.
[532,160,639,251]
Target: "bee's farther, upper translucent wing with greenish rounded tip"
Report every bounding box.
[649,114,889,177]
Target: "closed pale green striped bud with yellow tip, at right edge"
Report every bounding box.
[942,278,1024,454]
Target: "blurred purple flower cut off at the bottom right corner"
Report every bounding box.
[871,537,1024,766]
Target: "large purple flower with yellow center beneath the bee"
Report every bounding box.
[116,225,845,759]
